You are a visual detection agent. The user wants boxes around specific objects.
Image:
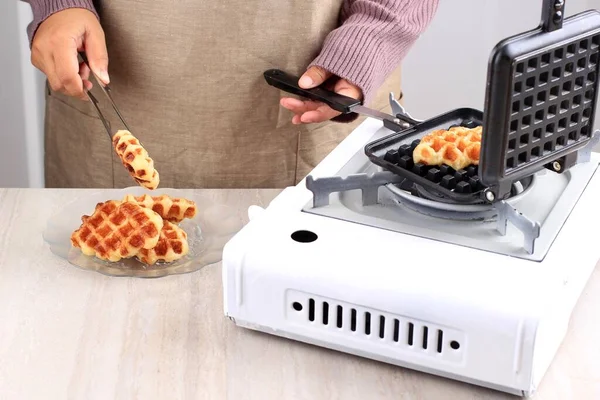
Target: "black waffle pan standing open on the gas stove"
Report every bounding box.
[365,0,600,203]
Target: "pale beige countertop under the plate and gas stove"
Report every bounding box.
[0,189,600,400]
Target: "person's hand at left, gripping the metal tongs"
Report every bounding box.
[31,8,109,100]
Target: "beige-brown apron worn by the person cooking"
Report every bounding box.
[45,0,400,188]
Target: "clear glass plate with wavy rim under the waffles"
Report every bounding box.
[43,186,242,278]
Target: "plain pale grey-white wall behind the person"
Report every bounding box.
[0,0,600,187]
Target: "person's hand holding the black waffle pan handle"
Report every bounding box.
[281,67,363,124]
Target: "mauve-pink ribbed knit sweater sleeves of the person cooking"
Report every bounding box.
[23,0,439,104]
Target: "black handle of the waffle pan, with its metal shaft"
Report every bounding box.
[263,69,421,126]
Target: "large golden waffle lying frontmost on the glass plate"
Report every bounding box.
[71,200,164,262]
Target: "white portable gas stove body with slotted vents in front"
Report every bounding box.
[223,119,600,396]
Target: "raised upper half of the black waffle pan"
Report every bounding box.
[479,0,600,198]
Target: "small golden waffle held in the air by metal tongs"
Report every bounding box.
[113,130,160,190]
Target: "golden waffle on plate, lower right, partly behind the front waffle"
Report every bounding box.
[136,221,189,265]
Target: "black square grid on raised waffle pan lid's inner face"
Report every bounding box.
[505,35,600,173]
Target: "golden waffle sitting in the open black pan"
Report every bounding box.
[413,126,482,171]
